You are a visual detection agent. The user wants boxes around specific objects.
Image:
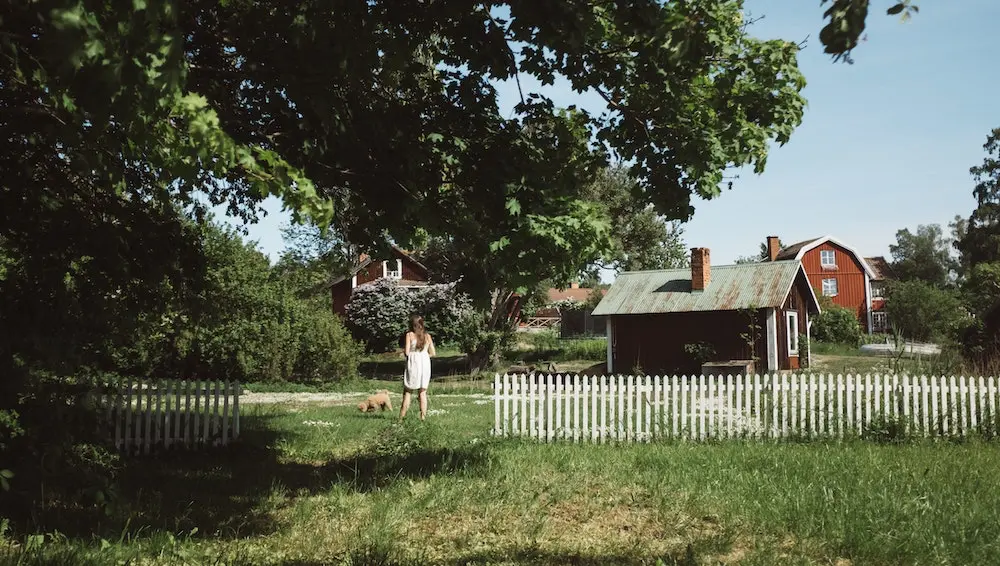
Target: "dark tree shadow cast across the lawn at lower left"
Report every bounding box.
[42,415,485,540]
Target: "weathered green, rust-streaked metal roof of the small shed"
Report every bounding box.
[593,260,818,315]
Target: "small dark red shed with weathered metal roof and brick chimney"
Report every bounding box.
[594,248,820,375]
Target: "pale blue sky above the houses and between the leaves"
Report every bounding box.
[217,0,1000,276]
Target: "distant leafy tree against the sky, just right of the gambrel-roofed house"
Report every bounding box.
[889,224,959,287]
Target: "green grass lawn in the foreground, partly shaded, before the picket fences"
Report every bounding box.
[0,383,1000,566]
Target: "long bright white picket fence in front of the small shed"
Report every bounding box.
[492,374,998,443]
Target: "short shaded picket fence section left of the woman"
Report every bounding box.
[94,379,243,454]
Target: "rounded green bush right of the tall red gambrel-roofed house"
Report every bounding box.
[885,280,967,341]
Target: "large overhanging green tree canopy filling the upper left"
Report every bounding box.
[7,0,920,384]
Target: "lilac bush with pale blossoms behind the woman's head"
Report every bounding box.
[346,279,472,352]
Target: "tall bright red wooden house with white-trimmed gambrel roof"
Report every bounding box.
[767,236,888,334]
